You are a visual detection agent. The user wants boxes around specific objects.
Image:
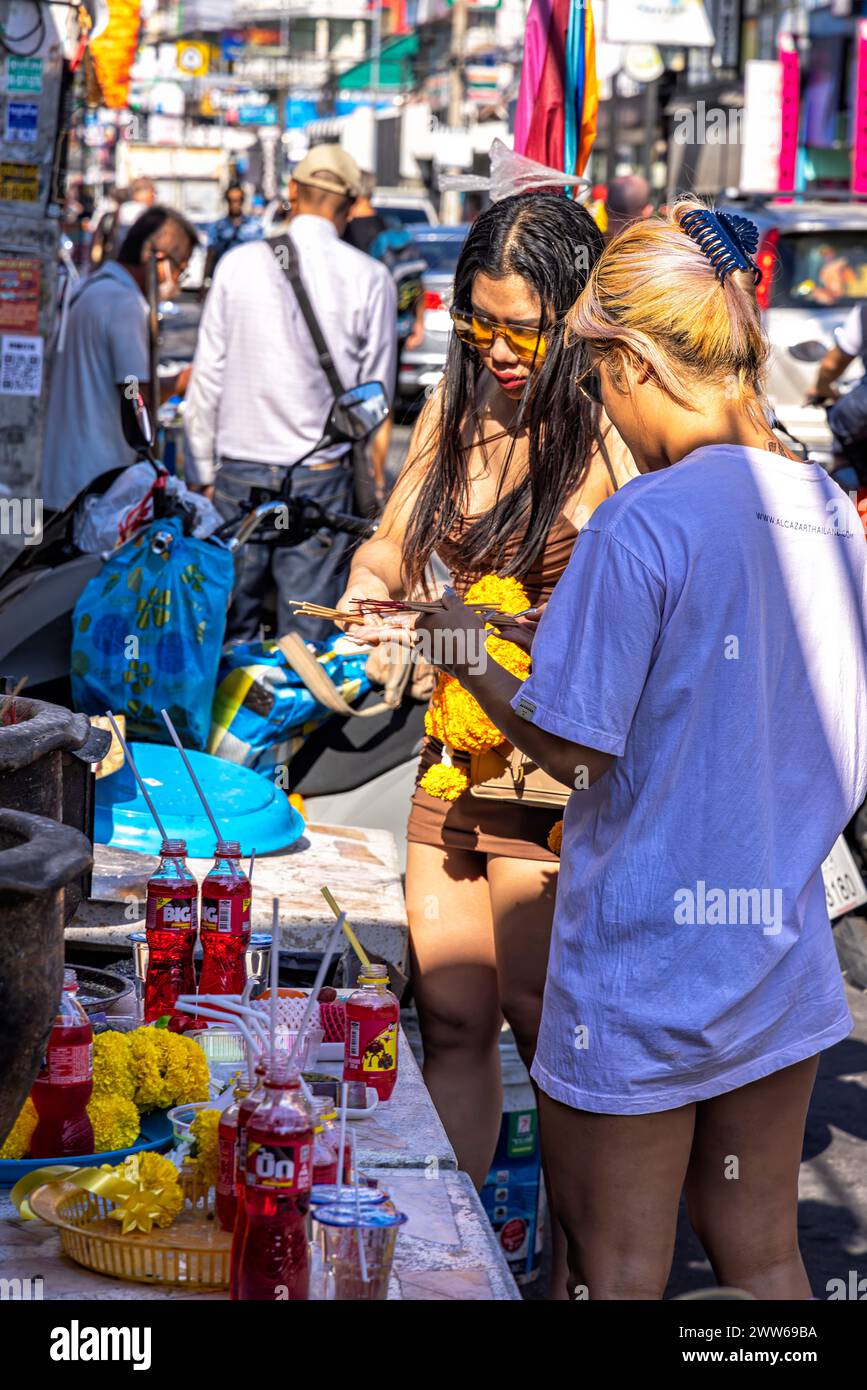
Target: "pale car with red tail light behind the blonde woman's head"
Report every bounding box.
[729,202,867,464]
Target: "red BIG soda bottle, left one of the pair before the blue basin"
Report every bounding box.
[145,840,199,1023]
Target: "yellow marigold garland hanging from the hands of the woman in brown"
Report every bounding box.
[418,574,531,801]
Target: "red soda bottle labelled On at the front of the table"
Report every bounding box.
[231,1058,313,1302]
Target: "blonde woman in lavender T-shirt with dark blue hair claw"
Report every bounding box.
[411,202,867,1300]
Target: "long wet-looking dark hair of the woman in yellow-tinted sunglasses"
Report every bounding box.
[403,193,603,588]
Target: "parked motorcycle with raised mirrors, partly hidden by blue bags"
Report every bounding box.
[0,382,425,855]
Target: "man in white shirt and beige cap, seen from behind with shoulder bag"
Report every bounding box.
[185,145,397,639]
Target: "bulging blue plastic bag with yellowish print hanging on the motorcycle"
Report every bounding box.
[72,517,235,748]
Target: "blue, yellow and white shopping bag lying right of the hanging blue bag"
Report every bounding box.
[207,632,371,771]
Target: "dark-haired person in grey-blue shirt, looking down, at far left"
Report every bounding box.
[42,207,196,510]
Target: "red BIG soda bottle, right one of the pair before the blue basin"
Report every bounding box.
[199,840,250,994]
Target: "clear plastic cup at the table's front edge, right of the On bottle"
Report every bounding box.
[313,1206,407,1302]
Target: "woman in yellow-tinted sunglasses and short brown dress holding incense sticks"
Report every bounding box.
[342,193,632,1212]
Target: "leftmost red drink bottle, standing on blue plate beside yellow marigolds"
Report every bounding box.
[31,970,93,1158]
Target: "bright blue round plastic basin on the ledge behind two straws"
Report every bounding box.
[93,744,304,859]
